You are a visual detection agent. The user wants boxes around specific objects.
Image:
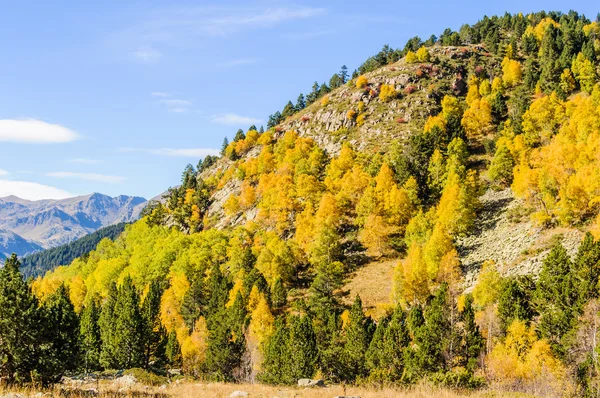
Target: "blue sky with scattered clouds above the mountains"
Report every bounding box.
[0,0,599,199]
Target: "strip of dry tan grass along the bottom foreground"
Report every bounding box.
[0,382,527,398]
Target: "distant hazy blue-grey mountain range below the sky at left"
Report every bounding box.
[0,193,147,259]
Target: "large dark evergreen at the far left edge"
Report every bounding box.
[0,254,40,382]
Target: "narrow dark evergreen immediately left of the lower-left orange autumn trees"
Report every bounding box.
[141,280,167,369]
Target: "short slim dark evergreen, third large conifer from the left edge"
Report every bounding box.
[79,299,102,371]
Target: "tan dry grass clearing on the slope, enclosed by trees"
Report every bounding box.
[343,259,399,318]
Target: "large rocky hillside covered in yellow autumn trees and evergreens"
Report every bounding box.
[18,12,600,396]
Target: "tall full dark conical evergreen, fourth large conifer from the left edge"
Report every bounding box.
[113,277,144,369]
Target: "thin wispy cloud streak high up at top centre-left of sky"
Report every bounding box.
[119,6,327,64]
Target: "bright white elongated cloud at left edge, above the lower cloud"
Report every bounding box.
[0,119,79,144]
